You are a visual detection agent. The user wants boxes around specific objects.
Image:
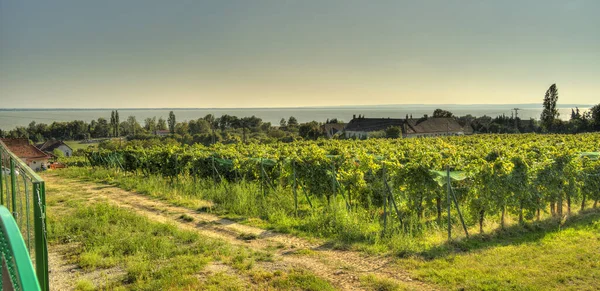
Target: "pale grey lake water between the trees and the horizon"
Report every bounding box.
[0,104,591,130]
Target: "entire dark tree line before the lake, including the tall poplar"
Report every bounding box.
[0,84,600,145]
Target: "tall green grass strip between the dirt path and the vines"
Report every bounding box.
[55,167,600,256]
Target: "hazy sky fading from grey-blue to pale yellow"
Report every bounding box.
[0,0,600,108]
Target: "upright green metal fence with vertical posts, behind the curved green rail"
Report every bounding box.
[0,141,49,290]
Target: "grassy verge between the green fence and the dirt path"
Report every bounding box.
[47,173,333,290]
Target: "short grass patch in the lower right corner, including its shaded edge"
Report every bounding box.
[397,210,600,290]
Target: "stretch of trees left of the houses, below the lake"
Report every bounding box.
[0,110,330,144]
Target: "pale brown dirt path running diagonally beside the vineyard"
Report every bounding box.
[44,175,435,290]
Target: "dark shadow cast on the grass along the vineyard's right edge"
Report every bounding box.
[417,208,600,260]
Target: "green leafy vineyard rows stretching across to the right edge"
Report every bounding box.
[71,134,600,246]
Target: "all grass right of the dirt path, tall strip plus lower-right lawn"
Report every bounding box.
[49,168,600,290]
